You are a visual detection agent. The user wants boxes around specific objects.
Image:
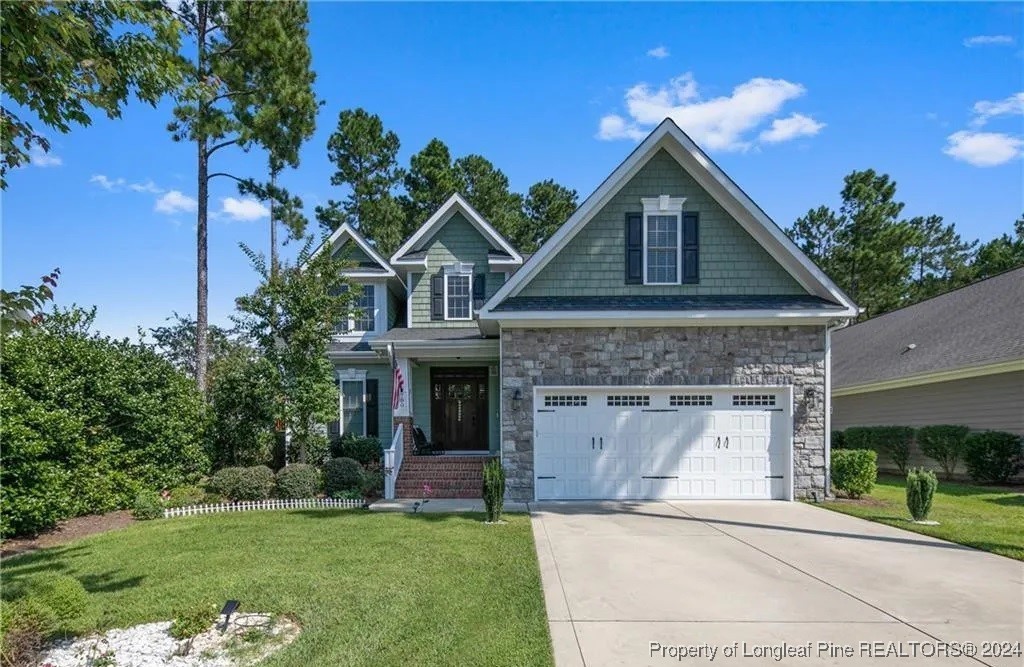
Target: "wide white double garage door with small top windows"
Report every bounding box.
[534,386,793,500]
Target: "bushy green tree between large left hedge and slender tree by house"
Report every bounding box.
[208,344,278,468]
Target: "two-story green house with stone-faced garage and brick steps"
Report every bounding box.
[330,120,857,500]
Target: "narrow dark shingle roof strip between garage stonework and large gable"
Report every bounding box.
[495,294,843,311]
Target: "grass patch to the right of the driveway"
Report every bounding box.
[821,476,1024,560]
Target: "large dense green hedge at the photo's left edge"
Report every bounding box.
[0,310,209,537]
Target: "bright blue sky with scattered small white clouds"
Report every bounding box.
[2,3,1024,335]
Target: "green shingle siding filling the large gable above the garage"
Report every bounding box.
[520,150,807,296]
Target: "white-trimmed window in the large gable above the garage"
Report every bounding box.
[641,195,686,285]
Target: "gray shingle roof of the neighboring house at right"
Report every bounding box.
[831,266,1024,390]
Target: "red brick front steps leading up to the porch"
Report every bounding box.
[395,456,490,498]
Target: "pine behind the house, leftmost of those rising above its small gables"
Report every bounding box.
[316,109,407,255]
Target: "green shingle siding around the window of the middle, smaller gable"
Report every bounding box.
[409,213,505,328]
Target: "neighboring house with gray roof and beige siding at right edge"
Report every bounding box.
[833,266,1024,442]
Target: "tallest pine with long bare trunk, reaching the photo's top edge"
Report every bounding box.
[168,0,317,390]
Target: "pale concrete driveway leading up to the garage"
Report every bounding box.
[530,502,1024,667]
